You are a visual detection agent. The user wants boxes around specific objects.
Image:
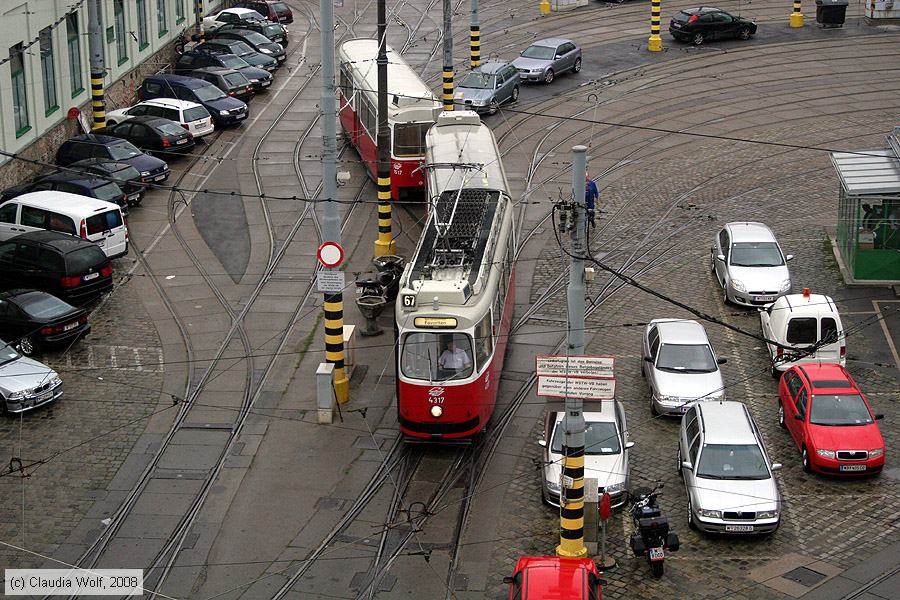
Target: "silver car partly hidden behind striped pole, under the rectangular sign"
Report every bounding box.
[538,400,634,507]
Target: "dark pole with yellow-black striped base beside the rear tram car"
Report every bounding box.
[375,0,397,256]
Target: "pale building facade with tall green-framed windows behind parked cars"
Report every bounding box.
[0,0,222,188]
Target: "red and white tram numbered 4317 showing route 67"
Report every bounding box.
[395,111,515,441]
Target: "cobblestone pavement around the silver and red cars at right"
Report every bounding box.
[488,32,900,599]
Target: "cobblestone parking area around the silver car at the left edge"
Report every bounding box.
[0,272,163,568]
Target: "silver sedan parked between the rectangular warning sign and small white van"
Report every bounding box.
[641,319,725,415]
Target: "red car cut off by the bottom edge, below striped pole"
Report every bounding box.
[503,556,606,600]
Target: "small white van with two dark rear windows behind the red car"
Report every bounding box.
[759,288,847,377]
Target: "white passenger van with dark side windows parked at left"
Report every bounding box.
[0,191,128,258]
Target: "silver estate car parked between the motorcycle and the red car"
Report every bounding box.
[678,402,781,534]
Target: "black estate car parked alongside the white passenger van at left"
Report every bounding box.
[0,231,112,306]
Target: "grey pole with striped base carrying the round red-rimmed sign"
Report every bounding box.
[319,0,350,404]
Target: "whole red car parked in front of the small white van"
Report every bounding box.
[778,364,884,475]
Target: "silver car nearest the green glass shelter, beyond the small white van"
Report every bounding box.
[709,222,794,306]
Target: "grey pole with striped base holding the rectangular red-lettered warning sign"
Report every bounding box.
[556,145,587,556]
